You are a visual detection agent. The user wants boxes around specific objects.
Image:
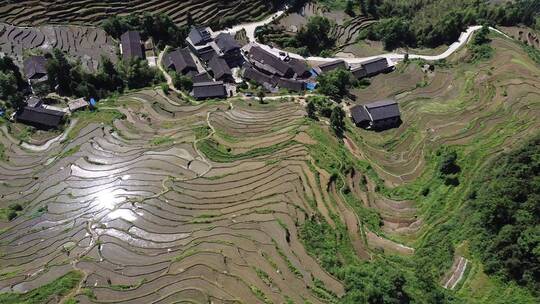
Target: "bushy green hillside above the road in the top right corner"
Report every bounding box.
[360,0,540,49]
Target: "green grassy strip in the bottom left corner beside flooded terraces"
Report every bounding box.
[0,271,82,304]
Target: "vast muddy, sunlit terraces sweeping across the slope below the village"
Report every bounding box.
[0,35,540,303]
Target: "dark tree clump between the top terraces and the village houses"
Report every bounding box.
[102,12,189,48]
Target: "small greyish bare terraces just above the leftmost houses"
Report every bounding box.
[0,23,117,71]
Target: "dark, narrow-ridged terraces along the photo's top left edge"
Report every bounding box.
[0,0,272,25]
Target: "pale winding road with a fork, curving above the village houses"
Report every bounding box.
[214,10,508,64]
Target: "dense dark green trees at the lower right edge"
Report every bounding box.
[470,136,540,295]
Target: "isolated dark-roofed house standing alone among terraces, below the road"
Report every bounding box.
[351,100,401,130]
